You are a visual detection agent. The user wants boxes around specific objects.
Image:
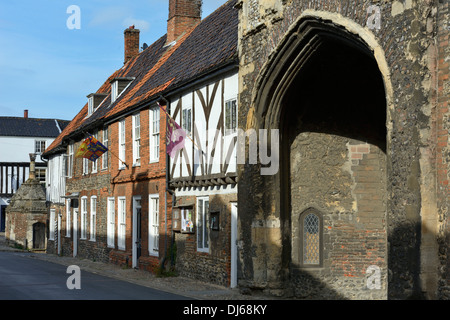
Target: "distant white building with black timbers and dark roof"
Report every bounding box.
[0,110,69,232]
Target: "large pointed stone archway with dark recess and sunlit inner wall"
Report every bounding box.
[243,16,390,298]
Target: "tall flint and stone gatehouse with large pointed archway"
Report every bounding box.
[236,0,450,299]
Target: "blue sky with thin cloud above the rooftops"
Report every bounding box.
[0,0,226,120]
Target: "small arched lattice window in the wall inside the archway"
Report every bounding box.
[299,209,322,267]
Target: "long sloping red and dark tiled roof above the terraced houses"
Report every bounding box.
[46,0,238,154]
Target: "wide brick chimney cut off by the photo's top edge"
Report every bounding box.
[167,0,202,43]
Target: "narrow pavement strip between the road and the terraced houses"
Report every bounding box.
[0,233,271,300]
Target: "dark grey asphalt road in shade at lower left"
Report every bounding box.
[0,252,190,300]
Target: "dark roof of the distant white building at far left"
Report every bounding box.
[0,117,69,138]
